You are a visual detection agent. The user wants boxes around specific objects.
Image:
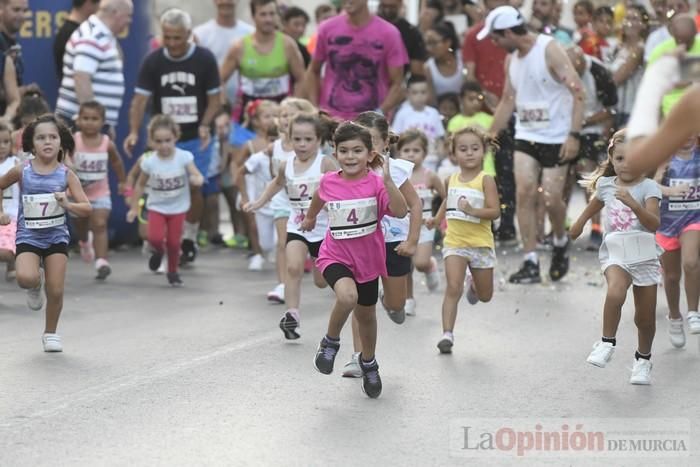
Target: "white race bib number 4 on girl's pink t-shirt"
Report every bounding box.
[326,198,377,240]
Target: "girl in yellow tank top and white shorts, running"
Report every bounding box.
[426,127,501,353]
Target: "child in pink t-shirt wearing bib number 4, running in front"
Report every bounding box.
[301,122,408,398]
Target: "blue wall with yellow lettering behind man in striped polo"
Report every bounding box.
[20,0,152,242]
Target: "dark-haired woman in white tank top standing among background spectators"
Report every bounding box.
[425,23,465,103]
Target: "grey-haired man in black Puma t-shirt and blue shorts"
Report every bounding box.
[124,8,221,262]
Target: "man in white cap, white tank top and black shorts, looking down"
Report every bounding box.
[477,5,585,284]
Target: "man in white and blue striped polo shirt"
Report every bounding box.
[56,0,134,136]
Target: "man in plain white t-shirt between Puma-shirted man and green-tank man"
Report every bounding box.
[193,0,255,106]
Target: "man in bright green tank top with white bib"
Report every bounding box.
[220,0,304,121]
